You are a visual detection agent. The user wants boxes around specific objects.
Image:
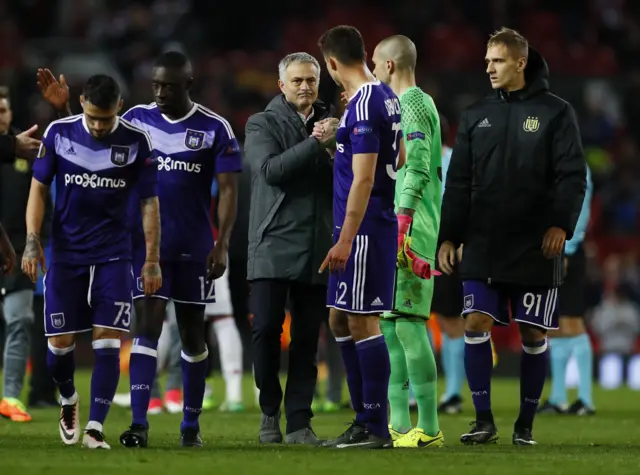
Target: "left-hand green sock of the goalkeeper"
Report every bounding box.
[380,318,411,433]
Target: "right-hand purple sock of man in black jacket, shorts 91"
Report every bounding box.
[515,338,549,430]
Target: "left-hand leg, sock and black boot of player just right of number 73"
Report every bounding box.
[120,297,167,447]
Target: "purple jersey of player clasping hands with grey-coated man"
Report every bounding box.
[333,81,402,233]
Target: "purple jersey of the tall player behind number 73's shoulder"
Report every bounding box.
[123,103,242,261]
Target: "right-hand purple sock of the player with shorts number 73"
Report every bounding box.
[89,338,120,424]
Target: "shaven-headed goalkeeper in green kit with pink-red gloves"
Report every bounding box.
[372,35,444,448]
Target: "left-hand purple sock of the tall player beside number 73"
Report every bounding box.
[129,337,158,427]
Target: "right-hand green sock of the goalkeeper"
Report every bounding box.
[396,318,440,436]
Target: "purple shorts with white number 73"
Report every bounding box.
[44,261,133,336]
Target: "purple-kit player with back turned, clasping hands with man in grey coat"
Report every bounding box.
[314,26,404,449]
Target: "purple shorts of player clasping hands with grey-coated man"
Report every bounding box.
[327,226,398,314]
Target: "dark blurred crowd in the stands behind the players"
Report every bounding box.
[0,0,640,353]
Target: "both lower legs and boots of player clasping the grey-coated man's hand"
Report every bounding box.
[325,309,393,449]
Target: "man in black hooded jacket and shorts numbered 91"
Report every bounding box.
[438,29,586,445]
